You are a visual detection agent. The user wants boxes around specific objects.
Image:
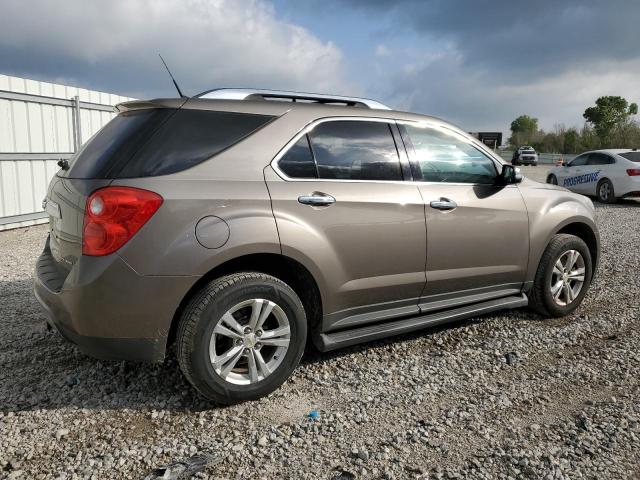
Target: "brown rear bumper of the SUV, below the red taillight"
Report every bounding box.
[34,238,197,362]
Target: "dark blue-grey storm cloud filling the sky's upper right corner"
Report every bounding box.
[340,0,640,78]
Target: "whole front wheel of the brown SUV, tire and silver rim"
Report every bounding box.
[529,234,593,317]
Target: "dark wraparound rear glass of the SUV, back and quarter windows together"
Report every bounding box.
[67,109,273,178]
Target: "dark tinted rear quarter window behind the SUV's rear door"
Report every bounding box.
[118,109,273,178]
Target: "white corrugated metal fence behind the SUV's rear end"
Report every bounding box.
[0,75,131,230]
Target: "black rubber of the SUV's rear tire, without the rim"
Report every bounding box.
[190,279,307,403]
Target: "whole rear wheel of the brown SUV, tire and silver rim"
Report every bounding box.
[176,272,307,405]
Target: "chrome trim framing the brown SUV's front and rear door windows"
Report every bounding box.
[269,116,508,188]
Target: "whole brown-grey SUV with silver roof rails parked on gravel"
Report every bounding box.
[35,90,600,403]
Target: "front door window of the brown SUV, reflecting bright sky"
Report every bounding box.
[400,125,498,184]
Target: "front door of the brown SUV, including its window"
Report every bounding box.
[400,123,529,311]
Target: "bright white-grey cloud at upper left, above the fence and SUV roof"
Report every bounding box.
[0,0,346,97]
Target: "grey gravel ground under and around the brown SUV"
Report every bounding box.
[0,177,640,479]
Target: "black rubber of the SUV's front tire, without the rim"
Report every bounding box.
[542,237,593,317]
